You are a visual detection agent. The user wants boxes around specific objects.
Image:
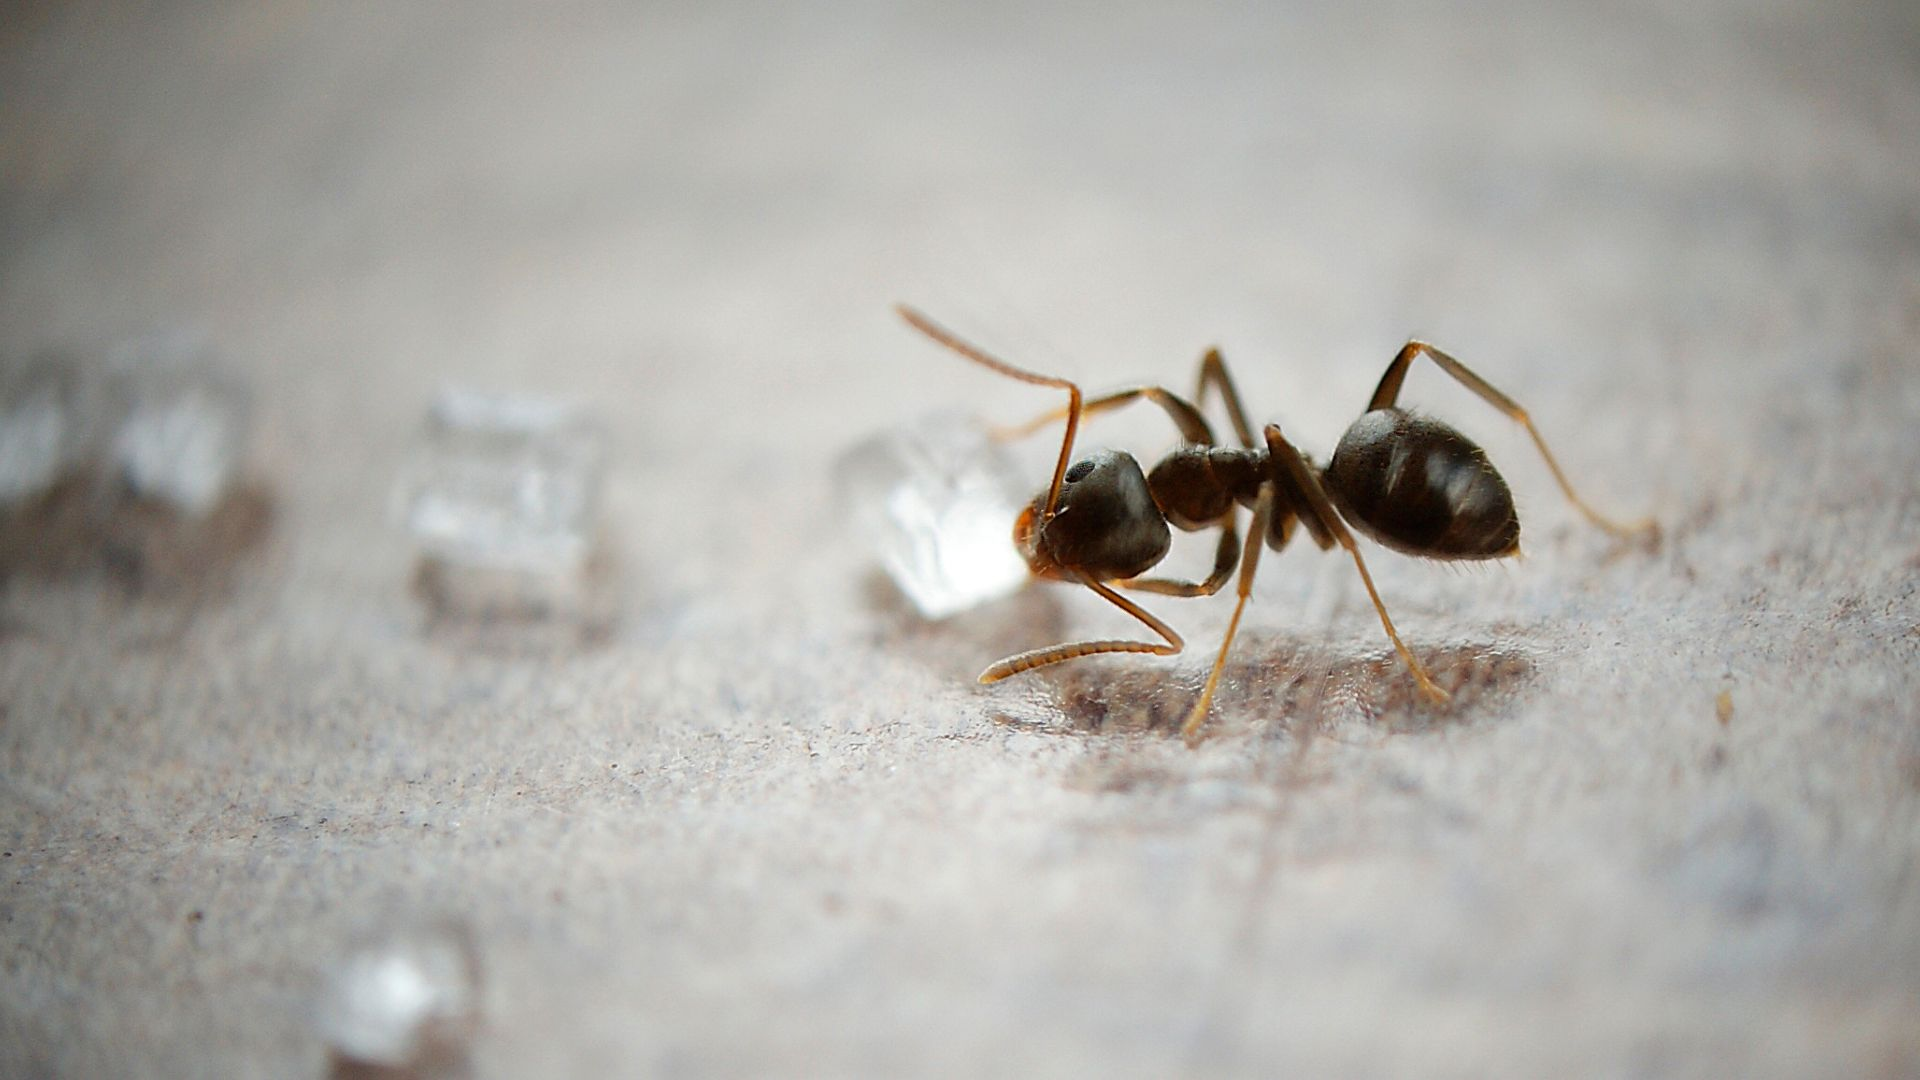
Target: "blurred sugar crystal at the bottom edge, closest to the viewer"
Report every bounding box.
[313,924,480,1076]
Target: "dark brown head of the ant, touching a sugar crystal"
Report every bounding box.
[1014,450,1173,580]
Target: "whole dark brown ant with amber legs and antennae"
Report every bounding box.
[895,304,1659,746]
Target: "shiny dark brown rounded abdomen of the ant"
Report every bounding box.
[1323,409,1521,559]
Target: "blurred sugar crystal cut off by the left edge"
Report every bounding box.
[0,356,86,505]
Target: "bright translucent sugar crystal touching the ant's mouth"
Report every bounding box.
[833,413,1031,619]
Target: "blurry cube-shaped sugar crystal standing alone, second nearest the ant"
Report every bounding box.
[399,390,605,613]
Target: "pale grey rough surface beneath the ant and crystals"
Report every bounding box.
[0,2,1920,1076]
